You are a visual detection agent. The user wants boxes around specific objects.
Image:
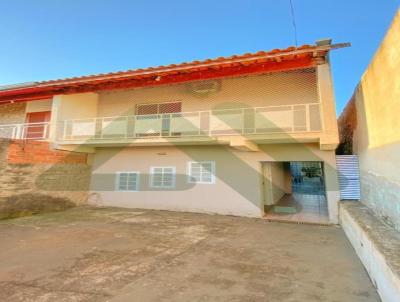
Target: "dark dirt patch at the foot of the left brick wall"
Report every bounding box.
[0,193,75,219]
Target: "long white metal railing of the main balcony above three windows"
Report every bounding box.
[57,103,322,141]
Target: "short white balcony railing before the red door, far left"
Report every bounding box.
[0,122,50,140]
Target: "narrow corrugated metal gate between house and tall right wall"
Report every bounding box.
[336,155,360,200]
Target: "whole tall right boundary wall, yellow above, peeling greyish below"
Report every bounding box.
[342,10,400,230]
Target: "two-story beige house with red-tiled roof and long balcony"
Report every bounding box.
[0,40,345,223]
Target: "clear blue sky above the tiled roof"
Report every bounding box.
[0,0,400,113]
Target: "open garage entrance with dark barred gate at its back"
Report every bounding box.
[262,161,329,223]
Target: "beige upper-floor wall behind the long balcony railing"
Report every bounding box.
[40,64,338,152]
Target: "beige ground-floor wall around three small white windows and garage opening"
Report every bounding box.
[91,144,338,223]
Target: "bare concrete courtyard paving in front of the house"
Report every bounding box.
[0,208,379,302]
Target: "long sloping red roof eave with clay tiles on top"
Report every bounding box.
[0,43,349,103]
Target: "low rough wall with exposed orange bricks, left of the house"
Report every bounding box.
[0,140,91,204]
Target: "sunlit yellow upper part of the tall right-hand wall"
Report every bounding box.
[357,11,400,148]
